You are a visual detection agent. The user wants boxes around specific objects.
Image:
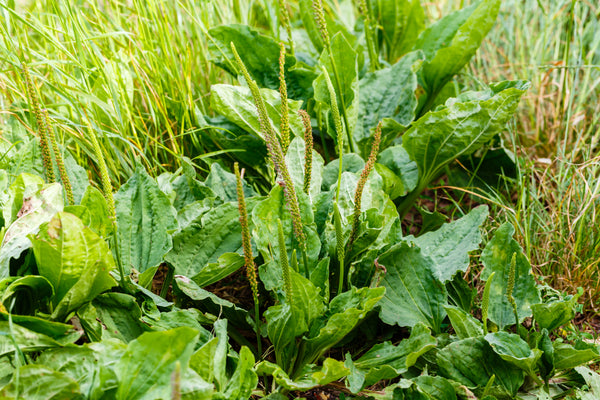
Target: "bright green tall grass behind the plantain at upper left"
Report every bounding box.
[0,0,268,186]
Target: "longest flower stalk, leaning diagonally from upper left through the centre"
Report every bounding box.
[231,42,308,275]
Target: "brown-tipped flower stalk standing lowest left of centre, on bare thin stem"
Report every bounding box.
[233,162,262,355]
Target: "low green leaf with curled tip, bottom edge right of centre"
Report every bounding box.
[346,324,437,393]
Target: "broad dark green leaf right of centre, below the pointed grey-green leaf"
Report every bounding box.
[379,242,447,332]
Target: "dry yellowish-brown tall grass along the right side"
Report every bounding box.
[429,0,600,313]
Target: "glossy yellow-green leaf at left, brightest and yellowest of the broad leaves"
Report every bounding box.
[30,212,117,320]
